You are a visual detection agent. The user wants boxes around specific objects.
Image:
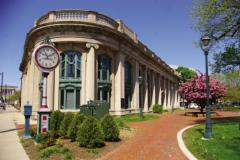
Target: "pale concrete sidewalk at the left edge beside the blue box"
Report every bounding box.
[0,107,29,160]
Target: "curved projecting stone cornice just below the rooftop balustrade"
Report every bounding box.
[19,9,179,78]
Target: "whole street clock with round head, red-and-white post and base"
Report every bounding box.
[32,40,60,141]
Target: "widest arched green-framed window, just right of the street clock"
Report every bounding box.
[59,51,81,109]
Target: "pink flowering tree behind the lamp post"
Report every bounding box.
[178,74,226,112]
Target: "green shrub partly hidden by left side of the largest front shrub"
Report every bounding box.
[67,112,85,141]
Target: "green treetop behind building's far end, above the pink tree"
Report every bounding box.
[176,66,196,82]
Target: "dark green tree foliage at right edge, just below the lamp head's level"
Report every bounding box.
[210,45,240,73]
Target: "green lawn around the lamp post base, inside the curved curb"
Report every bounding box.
[183,121,240,160]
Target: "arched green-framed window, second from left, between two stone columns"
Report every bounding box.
[98,54,112,102]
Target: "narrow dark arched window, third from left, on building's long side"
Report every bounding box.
[124,62,132,108]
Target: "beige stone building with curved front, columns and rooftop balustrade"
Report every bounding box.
[20,10,179,115]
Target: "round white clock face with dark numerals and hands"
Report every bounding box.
[35,45,59,70]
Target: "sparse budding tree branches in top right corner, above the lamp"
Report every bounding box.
[192,0,240,44]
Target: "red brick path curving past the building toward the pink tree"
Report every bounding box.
[98,112,240,160]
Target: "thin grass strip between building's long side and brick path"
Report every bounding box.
[115,114,159,122]
